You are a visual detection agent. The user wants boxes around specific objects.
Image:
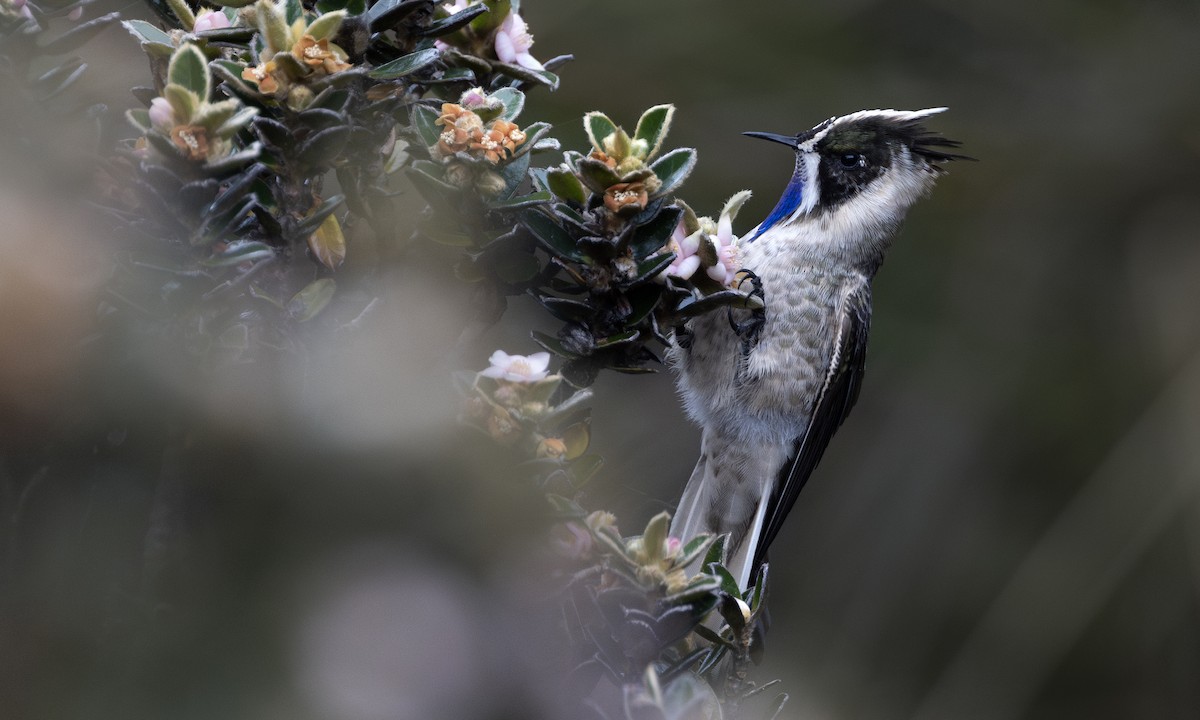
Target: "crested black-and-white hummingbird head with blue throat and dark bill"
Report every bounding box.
[744,108,966,240]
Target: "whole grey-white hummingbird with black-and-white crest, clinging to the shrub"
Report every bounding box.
[668,108,971,588]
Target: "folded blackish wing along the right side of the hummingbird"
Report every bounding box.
[750,277,871,575]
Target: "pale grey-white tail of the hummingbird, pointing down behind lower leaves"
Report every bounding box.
[671,430,787,589]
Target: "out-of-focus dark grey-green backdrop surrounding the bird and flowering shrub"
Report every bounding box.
[0,0,1200,720]
